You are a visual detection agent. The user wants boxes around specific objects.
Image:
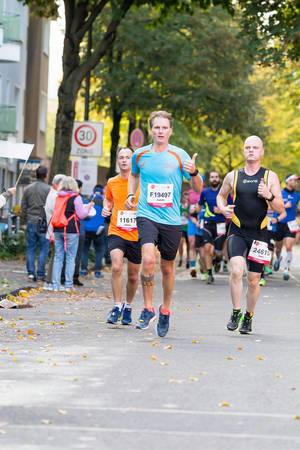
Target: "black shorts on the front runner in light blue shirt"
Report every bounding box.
[137,217,182,261]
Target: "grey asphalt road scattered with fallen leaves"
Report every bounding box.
[0,248,300,450]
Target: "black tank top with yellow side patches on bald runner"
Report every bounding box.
[232,167,269,231]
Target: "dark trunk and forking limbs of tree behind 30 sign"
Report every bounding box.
[50,0,133,179]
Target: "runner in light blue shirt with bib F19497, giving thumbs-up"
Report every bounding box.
[126,111,202,337]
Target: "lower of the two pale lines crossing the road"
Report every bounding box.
[5,424,300,442]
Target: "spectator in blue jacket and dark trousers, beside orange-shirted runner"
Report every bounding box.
[81,184,105,278]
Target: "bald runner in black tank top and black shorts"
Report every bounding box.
[217,136,284,334]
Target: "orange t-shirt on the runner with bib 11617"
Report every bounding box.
[105,175,139,241]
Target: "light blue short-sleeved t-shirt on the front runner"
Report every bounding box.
[131,144,191,225]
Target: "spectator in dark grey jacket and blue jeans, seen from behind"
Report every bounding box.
[21,166,50,281]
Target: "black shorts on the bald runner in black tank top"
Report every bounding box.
[227,223,268,273]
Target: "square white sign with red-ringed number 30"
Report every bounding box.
[71,121,103,158]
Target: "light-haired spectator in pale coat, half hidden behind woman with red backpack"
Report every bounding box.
[44,173,65,291]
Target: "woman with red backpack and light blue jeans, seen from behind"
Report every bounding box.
[51,177,94,291]
